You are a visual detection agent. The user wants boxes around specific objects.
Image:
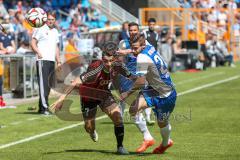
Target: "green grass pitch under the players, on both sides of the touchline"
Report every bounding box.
[0,64,240,160]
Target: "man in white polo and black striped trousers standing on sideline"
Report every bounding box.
[31,12,61,115]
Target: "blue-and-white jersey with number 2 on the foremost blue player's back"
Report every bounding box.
[136,45,174,97]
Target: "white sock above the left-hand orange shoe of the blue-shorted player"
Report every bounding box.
[135,113,153,140]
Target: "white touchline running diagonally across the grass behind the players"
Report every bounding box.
[0,76,240,149]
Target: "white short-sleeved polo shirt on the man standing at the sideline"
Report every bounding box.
[32,24,59,62]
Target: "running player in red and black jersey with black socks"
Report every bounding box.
[79,42,130,154]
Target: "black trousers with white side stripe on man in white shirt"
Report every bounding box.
[37,60,55,112]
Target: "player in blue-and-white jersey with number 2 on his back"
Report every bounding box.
[126,34,177,154]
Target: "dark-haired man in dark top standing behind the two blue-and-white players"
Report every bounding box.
[143,18,159,50]
